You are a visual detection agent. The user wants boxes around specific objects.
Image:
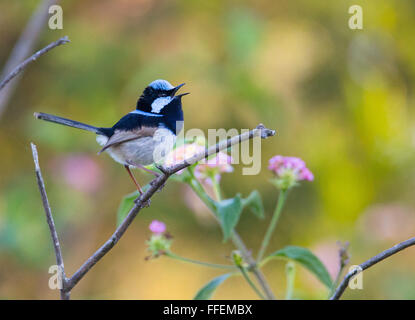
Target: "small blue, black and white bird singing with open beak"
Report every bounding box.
[34,79,189,194]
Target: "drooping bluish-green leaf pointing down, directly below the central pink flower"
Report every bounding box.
[215,194,243,241]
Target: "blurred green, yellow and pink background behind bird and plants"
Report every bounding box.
[0,0,415,299]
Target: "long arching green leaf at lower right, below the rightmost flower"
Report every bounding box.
[266,246,332,288]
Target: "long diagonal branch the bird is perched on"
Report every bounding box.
[65,124,275,292]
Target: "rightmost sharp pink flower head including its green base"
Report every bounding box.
[268,155,314,189]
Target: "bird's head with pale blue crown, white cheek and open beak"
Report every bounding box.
[137,79,188,114]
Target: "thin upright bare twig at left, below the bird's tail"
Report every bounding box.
[30,143,70,300]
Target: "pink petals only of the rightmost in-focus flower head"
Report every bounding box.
[268,155,314,181]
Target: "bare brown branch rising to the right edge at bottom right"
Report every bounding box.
[330,238,415,300]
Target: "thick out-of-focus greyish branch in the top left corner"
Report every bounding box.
[0,0,59,115]
